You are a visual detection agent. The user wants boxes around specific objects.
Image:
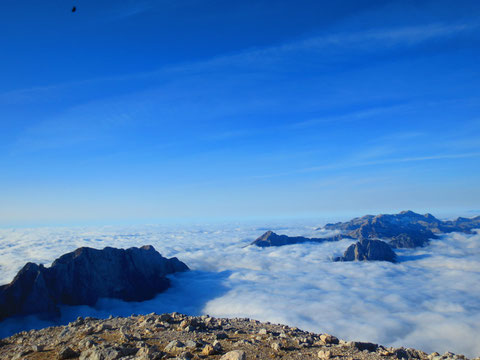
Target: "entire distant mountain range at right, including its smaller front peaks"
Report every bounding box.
[252,211,480,262]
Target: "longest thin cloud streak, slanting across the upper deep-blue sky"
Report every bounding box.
[0,22,478,103]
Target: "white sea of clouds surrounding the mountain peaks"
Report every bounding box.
[0,220,480,357]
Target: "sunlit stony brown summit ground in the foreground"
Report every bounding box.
[0,313,474,360]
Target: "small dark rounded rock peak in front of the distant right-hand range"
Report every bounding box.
[335,240,397,262]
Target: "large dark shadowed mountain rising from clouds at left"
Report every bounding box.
[0,246,188,320]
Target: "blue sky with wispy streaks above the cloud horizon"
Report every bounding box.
[0,0,480,226]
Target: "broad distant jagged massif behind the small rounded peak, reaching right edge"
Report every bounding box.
[324,211,480,248]
